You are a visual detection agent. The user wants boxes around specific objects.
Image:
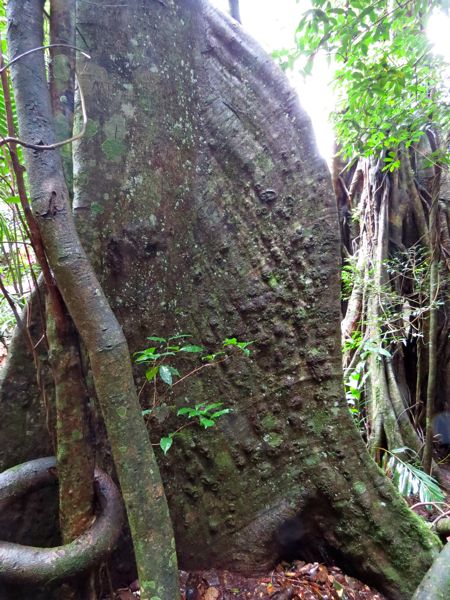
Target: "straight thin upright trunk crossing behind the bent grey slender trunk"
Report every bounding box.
[47,0,95,600]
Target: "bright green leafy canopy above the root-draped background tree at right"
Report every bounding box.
[286,0,450,162]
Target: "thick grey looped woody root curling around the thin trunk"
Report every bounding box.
[0,457,123,585]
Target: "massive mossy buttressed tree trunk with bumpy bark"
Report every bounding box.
[0,0,439,599]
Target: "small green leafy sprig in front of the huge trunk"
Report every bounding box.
[134,333,253,454]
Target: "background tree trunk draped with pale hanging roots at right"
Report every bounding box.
[340,138,449,471]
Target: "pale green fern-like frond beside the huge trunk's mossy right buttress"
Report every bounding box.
[382,447,445,502]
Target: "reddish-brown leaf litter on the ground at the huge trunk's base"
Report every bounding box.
[114,561,384,600]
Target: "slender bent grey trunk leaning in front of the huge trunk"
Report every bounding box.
[8,0,179,600]
